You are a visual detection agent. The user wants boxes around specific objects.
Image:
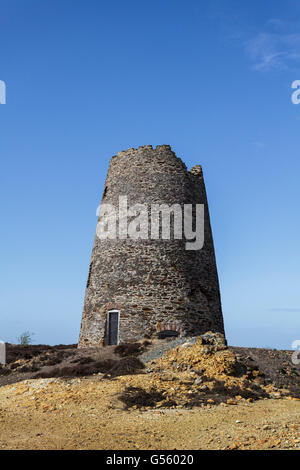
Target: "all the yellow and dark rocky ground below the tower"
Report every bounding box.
[0,334,300,450]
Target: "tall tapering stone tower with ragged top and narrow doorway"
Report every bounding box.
[78,145,224,347]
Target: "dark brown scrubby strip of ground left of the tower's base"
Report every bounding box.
[0,340,150,386]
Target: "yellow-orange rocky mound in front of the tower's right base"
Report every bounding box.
[120,332,298,408]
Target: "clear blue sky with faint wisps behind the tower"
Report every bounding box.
[0,0,300,348]
